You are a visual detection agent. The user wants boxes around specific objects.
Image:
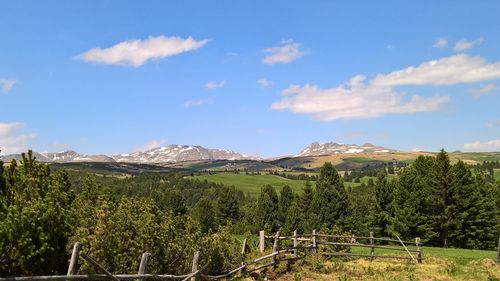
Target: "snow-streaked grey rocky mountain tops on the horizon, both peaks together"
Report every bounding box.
[0,142,395,164]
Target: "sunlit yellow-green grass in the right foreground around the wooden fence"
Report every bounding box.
[237,235,500,281]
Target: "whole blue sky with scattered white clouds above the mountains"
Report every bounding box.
[0,0,500,157]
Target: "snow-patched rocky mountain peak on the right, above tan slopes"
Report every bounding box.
[295,142,394,157]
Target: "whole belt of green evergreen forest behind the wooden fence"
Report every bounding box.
[0,150,500,276]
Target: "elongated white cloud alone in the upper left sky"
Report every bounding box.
[77,36,208,67]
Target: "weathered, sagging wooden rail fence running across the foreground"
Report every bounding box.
[0,230,423,281]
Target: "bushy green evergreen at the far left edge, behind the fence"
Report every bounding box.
[0,151,73,276]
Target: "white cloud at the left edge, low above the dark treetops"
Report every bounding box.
[0,123,36,154]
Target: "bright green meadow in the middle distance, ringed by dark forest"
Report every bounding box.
[191,173,314,196]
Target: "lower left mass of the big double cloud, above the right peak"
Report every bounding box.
[271,76,449,121]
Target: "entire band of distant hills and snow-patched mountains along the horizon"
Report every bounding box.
[0,142,500,174]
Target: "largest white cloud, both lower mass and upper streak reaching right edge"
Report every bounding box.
[271,54,500,120]
